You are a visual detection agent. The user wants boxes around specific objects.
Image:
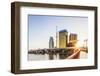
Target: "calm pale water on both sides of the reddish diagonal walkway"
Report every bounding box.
[28,51,87,61]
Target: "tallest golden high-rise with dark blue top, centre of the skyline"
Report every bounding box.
[59,29,68,48]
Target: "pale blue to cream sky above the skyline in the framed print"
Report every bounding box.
[28,15,88,50]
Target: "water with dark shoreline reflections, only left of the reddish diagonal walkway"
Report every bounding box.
[28,49,73,60]
